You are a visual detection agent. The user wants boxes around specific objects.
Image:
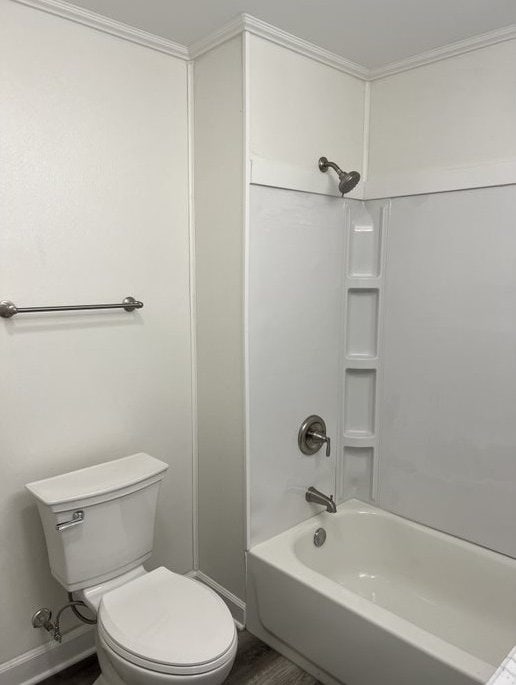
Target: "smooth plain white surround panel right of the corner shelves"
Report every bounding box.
[378,186,516,556]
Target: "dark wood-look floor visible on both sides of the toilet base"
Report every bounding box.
[42,630,320,685]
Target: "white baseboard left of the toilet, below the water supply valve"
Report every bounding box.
[0,625,95,685]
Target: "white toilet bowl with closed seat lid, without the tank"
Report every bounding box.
[87,567,237,685]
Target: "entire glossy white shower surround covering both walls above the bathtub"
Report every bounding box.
[248,180,516,556]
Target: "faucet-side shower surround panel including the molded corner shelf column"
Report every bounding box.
[248,186,389,546]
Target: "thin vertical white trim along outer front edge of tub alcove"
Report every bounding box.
[242,31,251,549]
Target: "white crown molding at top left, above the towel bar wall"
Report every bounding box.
[13,0,190,60]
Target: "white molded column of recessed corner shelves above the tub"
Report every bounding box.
[337,200,389,502]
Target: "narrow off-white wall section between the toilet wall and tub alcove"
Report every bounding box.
[194,36,245,598]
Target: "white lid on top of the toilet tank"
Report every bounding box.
[25,452,168,506]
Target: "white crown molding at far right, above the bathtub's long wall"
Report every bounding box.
[368,24,516,81]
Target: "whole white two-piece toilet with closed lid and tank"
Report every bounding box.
[26,453,238,685]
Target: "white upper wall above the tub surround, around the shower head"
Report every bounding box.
[246,34,516,199]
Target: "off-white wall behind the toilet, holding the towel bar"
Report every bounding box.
[0,0,192,662]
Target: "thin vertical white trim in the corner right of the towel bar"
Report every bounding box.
[186,62,199,570]
